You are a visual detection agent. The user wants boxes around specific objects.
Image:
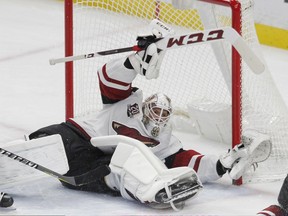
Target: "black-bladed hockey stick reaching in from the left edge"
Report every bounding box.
[0,148,110,186]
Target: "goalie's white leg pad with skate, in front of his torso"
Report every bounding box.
[105,138,202,209]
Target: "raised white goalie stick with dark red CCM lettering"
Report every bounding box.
[50,27,265,74]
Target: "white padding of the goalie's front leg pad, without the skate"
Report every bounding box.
[105,136,202,208]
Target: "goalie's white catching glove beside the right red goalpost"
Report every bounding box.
[220,131,272,180]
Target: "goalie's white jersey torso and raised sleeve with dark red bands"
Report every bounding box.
[69,58,182,159]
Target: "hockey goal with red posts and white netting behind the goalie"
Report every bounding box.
[65,0,288,184]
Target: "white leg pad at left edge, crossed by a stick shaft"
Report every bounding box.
[0,134,68,185]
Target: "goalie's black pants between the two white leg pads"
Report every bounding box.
[29,122,120,196]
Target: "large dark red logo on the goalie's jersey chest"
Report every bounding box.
[112,121,160,147]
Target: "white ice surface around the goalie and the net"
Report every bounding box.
[0,0,288,215]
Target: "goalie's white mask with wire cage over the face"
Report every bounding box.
[143,93,172,137]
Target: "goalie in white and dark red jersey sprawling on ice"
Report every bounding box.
[29,25,267,209]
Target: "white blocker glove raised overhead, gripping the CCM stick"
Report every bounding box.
[128,29,165,80]
